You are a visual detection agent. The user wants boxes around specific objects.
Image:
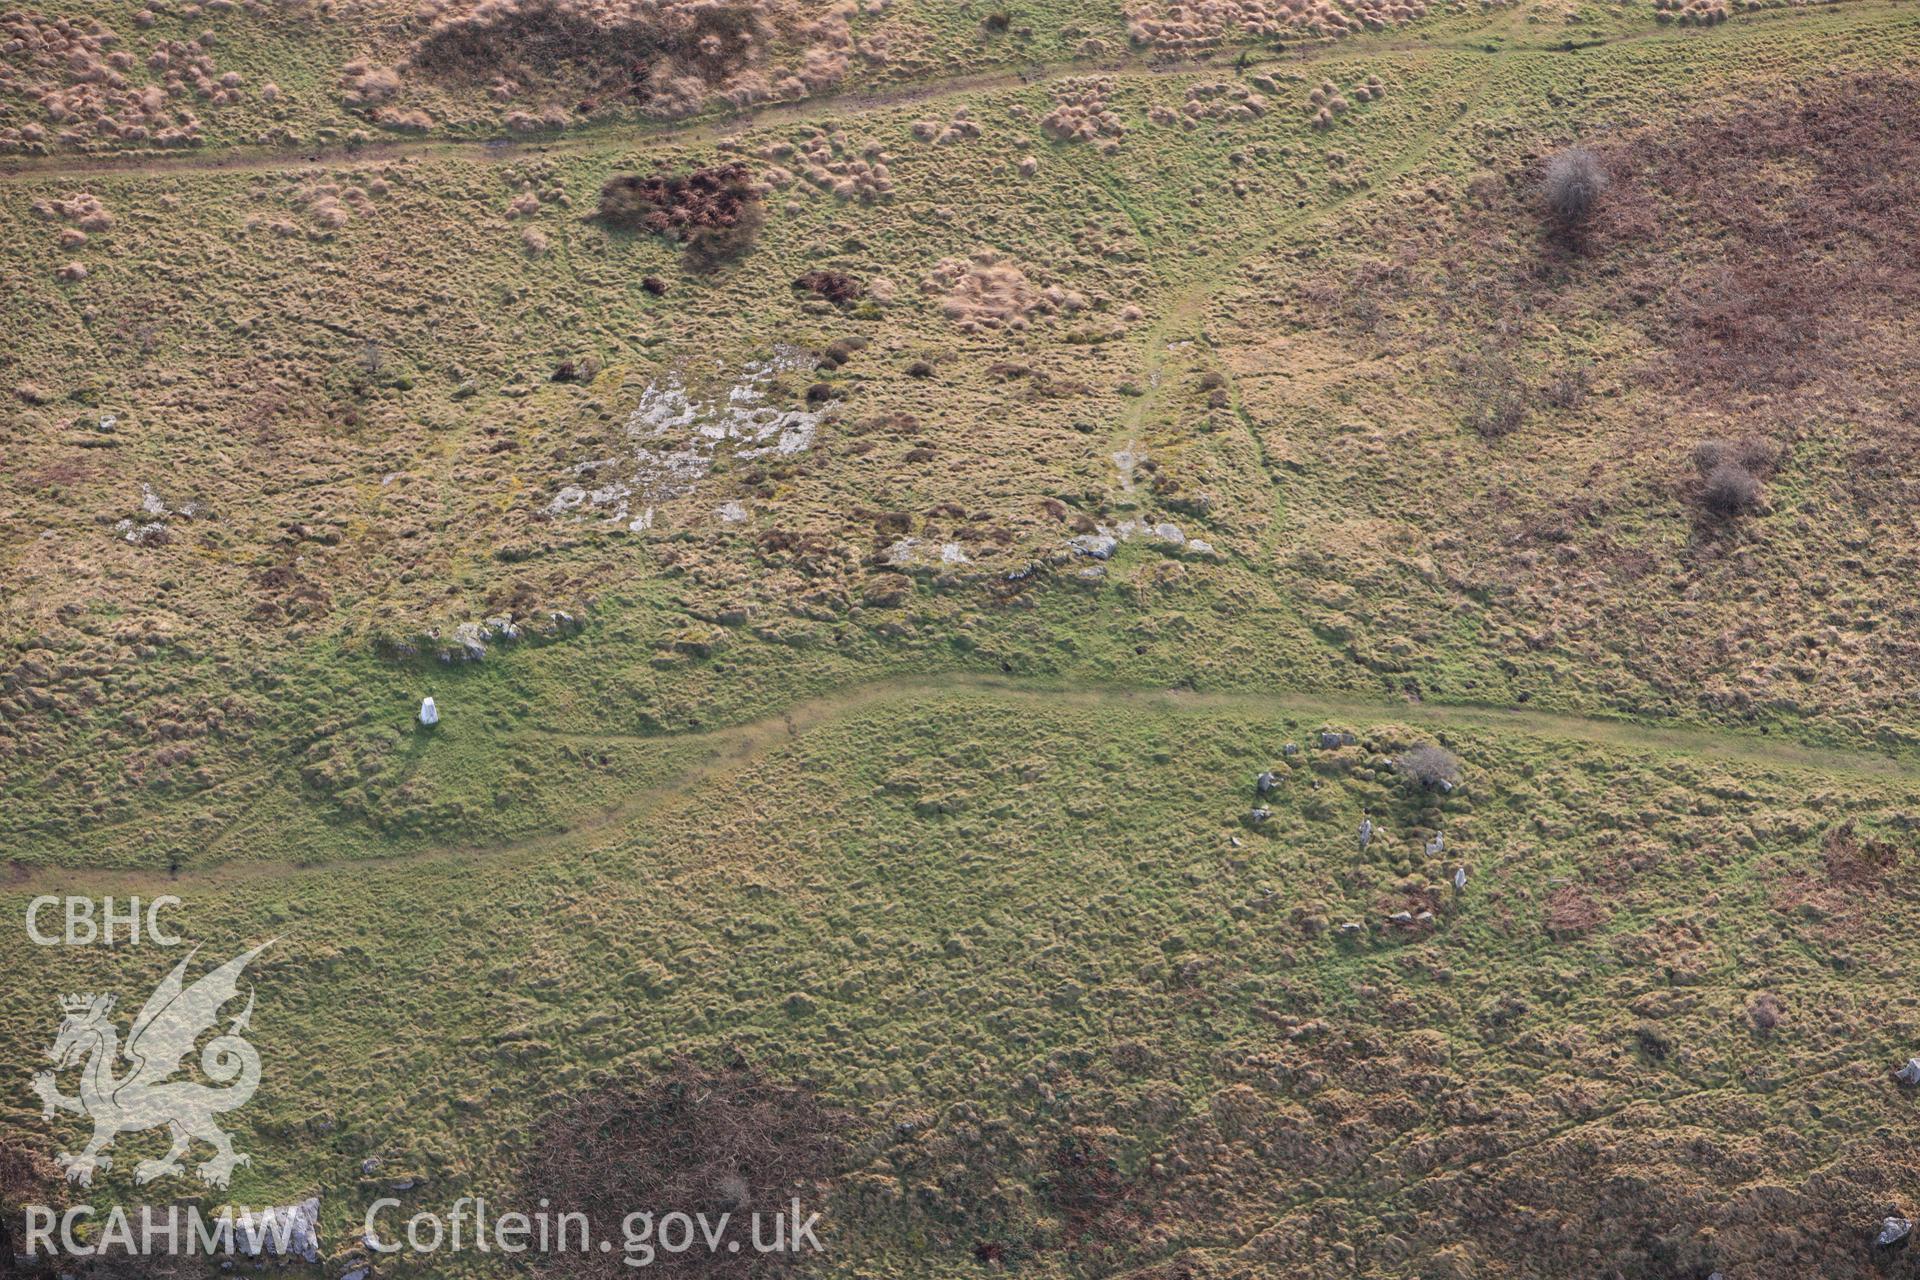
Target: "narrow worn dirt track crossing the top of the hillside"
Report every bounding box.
[0,0,1903,182]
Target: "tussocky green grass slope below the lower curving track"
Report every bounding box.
[0,689,1916,1274]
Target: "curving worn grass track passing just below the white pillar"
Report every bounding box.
[10,674,1920,892]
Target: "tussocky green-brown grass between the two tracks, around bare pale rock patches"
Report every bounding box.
[4,8,1908,865]
